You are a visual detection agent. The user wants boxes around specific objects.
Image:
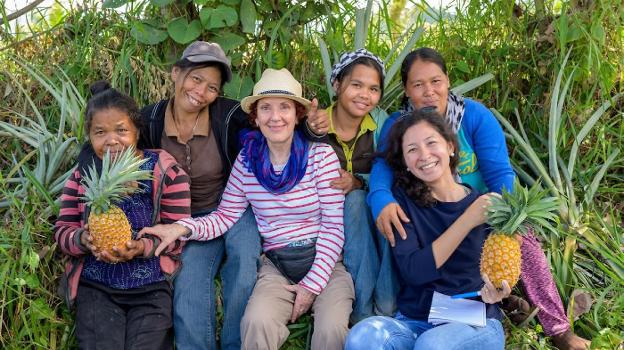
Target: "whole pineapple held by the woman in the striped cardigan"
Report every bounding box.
[82,147,151,254]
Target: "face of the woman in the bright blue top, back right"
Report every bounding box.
[404,60,450,115]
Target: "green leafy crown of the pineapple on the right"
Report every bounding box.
[487,179,559,235]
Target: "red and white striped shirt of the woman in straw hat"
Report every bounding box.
[177,143,344,295]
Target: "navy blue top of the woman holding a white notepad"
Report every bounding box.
[392,186,502,320]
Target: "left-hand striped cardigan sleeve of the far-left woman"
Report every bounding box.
[54,170,88,256]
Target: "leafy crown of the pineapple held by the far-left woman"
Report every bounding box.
[82,147,152,214]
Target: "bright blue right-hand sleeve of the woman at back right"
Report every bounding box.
[462,98,516,193]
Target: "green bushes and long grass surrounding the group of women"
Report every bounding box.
[0,0,624,349]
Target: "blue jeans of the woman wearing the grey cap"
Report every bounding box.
[173,208,261,350]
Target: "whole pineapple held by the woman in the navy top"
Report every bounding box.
[481,180,558,288]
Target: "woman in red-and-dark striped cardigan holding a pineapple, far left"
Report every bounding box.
[54,82,191,350]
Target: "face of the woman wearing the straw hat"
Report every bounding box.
[255,97,297,146]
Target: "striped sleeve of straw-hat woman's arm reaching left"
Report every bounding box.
[177,155,249,241]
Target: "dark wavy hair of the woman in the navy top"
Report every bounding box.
[384,109,459,206]
